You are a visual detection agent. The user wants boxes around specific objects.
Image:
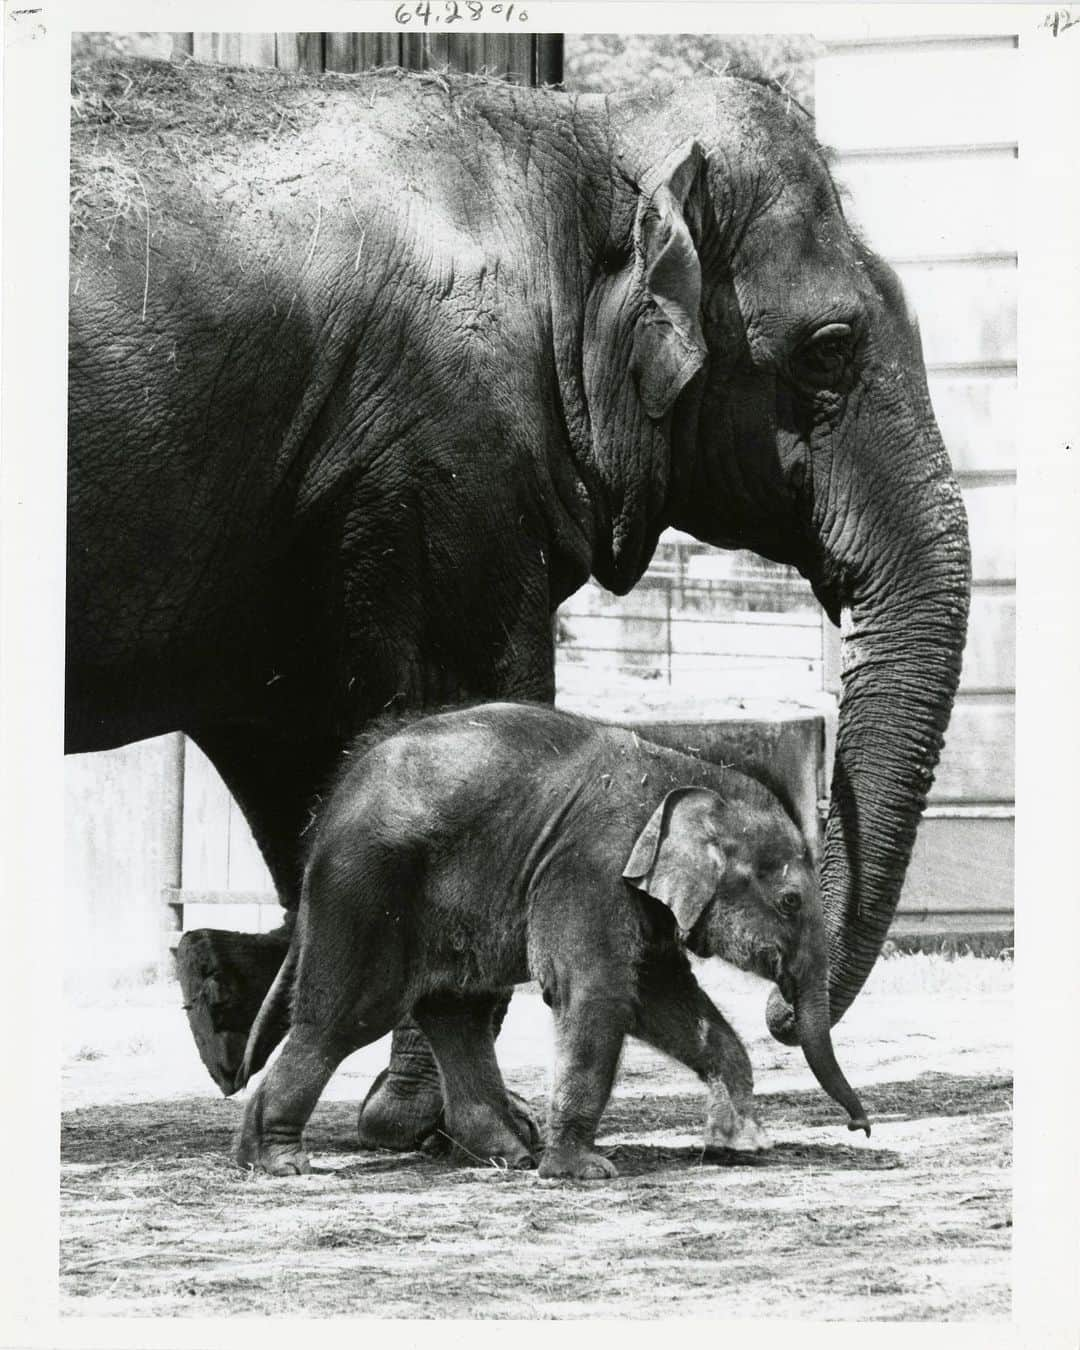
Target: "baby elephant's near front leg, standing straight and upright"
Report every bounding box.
[540,973,633,1181]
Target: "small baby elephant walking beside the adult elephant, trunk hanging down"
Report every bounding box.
[238,703,869,1177]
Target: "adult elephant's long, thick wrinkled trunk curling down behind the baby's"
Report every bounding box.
[768,437,971,1045]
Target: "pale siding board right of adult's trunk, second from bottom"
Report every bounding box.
[930,694,1017,802]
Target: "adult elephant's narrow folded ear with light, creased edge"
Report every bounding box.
[630,140,706,420]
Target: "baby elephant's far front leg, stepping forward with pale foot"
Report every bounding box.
[633,952,772,1153]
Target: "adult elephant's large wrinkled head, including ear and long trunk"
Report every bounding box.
[582,80,971,1044]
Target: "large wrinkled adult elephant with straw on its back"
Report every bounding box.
[68,63,969,1146]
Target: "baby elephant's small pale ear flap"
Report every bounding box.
[622,787,724,933]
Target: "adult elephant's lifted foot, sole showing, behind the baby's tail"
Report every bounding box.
[176,927,289,1096]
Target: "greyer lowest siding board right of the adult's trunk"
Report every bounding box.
[900,818,1014,917]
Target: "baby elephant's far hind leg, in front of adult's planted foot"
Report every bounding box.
[414,994,540,1168]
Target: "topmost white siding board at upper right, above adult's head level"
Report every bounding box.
[814,47,1019,150]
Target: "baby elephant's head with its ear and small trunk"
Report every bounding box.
[622,784,869,1134]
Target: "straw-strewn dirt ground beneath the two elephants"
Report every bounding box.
[61,956,1013,1320]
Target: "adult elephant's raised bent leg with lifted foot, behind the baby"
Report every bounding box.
[177,726,338,1095]
